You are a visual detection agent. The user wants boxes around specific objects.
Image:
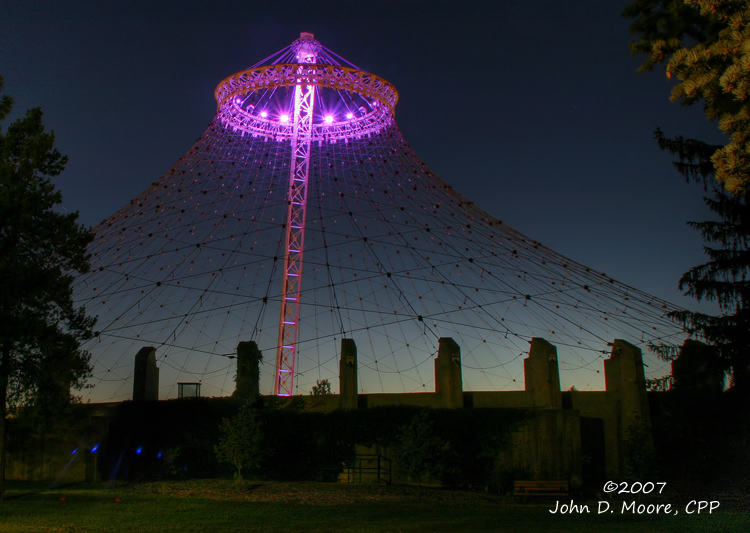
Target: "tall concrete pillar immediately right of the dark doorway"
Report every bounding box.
[604,339,654,474]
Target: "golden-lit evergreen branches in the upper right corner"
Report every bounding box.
[623,0,750,194]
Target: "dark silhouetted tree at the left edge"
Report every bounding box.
[0,78,94,498]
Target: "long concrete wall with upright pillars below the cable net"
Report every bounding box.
[7,338,653,487]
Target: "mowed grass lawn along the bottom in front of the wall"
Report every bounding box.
[0,480,750,533]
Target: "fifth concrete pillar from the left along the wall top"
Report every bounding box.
[523,337,562,408]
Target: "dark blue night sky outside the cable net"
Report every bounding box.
[0,0,723,309]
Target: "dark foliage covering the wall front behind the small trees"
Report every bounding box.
[89,398,525,487]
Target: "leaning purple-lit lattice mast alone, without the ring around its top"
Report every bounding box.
[274,33,320,396]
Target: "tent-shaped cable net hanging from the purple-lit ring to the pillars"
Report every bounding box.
[75,34,684,401]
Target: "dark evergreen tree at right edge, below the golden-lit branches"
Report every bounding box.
[655,130,750,390]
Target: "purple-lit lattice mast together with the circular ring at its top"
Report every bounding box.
[206,33,398,396]
